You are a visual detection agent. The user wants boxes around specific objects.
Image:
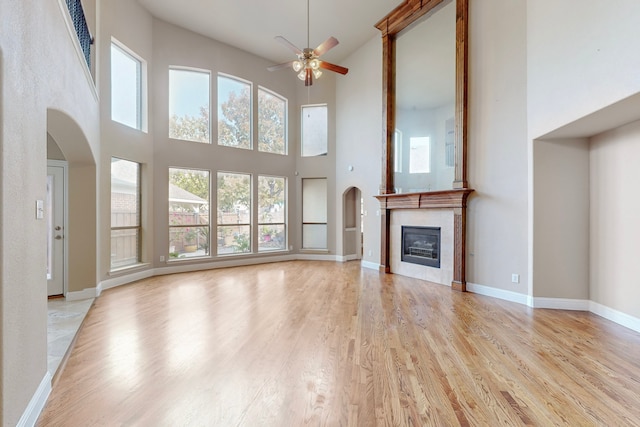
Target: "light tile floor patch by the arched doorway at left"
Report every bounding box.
[47,298,94,376]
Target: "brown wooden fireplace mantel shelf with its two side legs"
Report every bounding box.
[375,188,473,292]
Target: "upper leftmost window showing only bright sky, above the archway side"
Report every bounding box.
[111,42,143,130]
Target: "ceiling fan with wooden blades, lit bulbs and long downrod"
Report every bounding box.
[267,0,349,86]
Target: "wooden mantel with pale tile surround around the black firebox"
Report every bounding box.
[376,188,473,291]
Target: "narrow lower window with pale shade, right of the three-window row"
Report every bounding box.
[302,178,327,249]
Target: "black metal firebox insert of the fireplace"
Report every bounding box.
[401,225,440,268]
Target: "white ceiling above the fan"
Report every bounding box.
[138,0,402,64]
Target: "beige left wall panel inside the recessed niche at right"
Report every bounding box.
[532,139,589,300]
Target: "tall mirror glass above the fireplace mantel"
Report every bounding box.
[393,0,456,193]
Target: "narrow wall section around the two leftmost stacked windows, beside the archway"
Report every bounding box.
[96,0,157,280]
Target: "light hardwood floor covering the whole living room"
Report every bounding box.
[38,261,640,426]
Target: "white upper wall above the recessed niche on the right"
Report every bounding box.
[528,0,640,139]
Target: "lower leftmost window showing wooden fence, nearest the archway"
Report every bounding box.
[111,157,142,270]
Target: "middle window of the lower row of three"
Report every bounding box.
[217,172,251,255]
